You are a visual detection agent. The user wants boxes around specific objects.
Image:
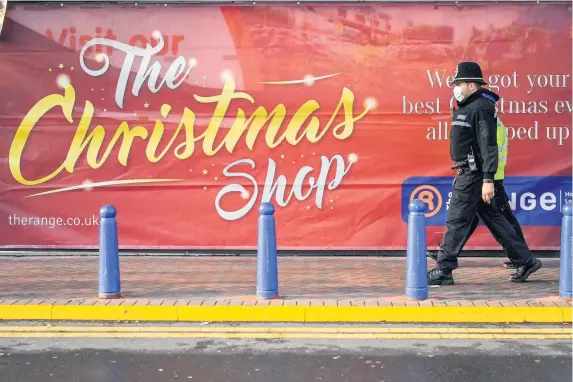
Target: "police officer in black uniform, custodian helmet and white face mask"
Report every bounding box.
[428,62,542,285]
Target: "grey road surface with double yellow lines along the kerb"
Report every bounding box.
[0,323,572,382]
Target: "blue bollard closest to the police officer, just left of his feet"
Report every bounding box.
[406,199,428,300]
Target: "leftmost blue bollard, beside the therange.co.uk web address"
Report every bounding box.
[98,205,121,299]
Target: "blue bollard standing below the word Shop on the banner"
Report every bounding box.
[257,202,279,299]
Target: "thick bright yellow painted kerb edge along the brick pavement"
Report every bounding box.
[0,305,573,323]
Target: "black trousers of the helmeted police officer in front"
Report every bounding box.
[438,169,532,272]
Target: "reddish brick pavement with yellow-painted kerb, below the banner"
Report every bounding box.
[0,256,572,323]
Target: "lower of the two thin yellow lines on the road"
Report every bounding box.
[0,332,572,340]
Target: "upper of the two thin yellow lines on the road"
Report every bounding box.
[0,325,573,334]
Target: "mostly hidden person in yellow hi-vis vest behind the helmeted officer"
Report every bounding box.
[427,89,525,269]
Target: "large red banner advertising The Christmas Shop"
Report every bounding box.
[0,2,572,250]
